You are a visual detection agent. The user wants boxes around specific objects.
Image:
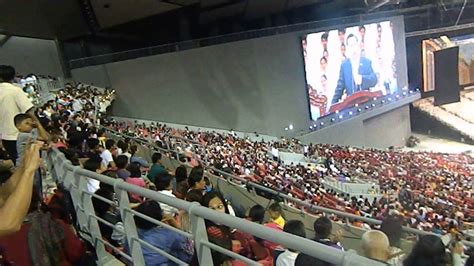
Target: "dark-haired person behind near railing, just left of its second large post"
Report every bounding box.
[92,183,125,247]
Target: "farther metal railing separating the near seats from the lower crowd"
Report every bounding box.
[102,129,474,247]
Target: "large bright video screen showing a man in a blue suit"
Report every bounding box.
[302,21,398,120]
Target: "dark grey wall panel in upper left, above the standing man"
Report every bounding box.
[0,35,63,77]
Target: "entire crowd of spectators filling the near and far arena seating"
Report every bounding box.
[0,66,472,266]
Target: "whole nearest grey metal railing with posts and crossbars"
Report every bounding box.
[47,148,382,265]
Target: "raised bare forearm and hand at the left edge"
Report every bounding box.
[0,142,43,236]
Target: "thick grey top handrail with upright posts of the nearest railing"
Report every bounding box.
[48,148,382,265]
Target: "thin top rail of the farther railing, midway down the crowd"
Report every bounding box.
[103,127,474,247]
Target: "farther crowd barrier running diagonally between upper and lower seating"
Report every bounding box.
[106,128,474,247]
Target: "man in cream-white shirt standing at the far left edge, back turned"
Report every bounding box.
[0,65,36,162]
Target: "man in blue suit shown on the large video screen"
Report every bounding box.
[332,34,377,104]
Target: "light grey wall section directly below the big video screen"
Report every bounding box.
[298,105,411,149]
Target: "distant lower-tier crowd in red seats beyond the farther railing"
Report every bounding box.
[107,118,474,234]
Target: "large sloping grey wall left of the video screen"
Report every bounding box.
[72,18,407,138]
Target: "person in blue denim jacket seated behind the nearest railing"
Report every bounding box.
[134,201,193,265]
